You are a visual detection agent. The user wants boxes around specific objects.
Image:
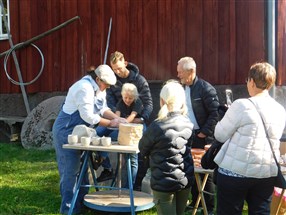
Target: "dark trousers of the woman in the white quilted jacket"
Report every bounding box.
[217,172,274,215]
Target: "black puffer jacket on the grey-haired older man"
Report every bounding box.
[189,77,219,137]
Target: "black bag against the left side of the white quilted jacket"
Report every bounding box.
[201,140,223,169]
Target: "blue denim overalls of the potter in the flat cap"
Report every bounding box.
[53,111,89,214]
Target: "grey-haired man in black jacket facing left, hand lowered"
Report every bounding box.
[177,57,219,214]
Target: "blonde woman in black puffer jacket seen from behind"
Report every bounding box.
[139,81,194,215]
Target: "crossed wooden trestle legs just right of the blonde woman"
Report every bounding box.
[192,173,209,215]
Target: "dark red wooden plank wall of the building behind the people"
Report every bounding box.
[0,0,286,93]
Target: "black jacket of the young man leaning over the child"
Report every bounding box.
[106,63,153,120]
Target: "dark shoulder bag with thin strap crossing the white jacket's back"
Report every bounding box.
[248,99,286,189]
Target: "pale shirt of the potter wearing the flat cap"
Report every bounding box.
[63,75,109,125]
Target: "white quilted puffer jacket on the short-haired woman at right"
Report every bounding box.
[214,96,286,178]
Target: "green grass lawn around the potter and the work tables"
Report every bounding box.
[0,143,247,215]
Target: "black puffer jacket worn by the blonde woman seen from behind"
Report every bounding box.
[139,112,194,192]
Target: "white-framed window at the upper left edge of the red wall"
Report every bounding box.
[0,0,10,40]
